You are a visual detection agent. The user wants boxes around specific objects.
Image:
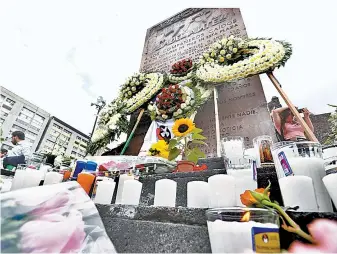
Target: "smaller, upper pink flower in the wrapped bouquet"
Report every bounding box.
[31,192,69,217]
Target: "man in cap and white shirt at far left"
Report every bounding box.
[1,131,31,167]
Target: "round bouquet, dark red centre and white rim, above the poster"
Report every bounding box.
[148,84,195,121]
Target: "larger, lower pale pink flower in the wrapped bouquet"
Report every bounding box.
[19,210,85,253]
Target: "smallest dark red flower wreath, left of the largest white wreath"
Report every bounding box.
[168,59,194,83]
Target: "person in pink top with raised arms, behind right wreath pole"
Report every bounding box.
[271,107,314,141]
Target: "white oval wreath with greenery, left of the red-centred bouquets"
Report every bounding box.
[118,73,164,114]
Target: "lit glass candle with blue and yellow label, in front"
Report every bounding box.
[206,207,280,253]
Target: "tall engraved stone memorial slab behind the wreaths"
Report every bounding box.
[130,8,275,157]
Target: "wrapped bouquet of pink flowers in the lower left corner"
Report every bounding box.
[0,182,116,253]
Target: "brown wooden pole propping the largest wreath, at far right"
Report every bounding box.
[267,72,318,142]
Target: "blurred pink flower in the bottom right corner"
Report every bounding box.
[289,219,337,253]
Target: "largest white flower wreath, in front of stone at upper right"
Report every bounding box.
[196,37,292,83]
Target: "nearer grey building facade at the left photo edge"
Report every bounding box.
[0,86,50,152]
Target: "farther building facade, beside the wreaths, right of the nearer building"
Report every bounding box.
[37,116,90,158]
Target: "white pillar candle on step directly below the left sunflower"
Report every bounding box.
[154,179,177,207]
